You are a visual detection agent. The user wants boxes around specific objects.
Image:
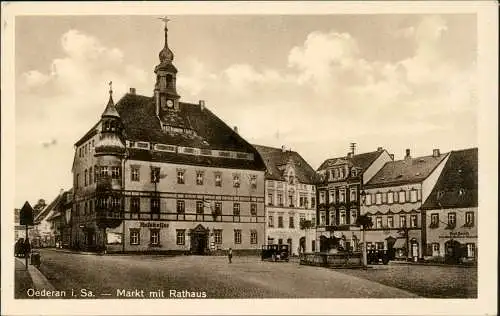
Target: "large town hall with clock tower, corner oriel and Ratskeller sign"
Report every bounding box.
[71,18,266,254]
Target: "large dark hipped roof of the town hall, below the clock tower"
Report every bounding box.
[73,93,265,171]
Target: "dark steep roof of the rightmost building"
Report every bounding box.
[422,148,478,210]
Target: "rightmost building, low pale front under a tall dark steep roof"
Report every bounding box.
[421,148,478,263]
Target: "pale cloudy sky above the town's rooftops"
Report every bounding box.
[15,14,478,206]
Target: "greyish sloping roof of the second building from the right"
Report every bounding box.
[365,154,448,188]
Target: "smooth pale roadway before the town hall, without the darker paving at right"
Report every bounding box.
[33,250,417,298]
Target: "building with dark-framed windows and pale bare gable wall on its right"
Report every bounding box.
[316,147,392,252]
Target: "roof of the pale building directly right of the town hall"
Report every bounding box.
[253,145,316,184]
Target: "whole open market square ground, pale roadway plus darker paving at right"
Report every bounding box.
[16,249,477,299]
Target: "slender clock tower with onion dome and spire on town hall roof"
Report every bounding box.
[154,17,180,118]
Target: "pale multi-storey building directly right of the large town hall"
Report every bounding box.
[254,145,317,255]
